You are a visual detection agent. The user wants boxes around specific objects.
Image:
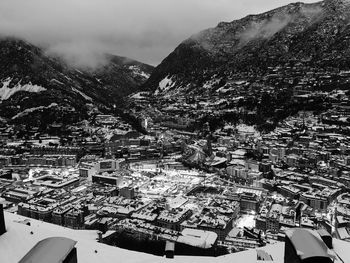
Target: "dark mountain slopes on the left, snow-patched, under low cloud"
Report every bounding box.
[0,38,153,125]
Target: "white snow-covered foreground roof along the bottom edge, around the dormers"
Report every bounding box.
[0,212,350,263]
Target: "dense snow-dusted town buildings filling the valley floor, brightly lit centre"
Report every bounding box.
[0,91,350,254]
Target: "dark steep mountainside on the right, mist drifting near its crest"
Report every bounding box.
[144,0,350,94]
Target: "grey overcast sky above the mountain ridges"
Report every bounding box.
[0,0,316,66]
